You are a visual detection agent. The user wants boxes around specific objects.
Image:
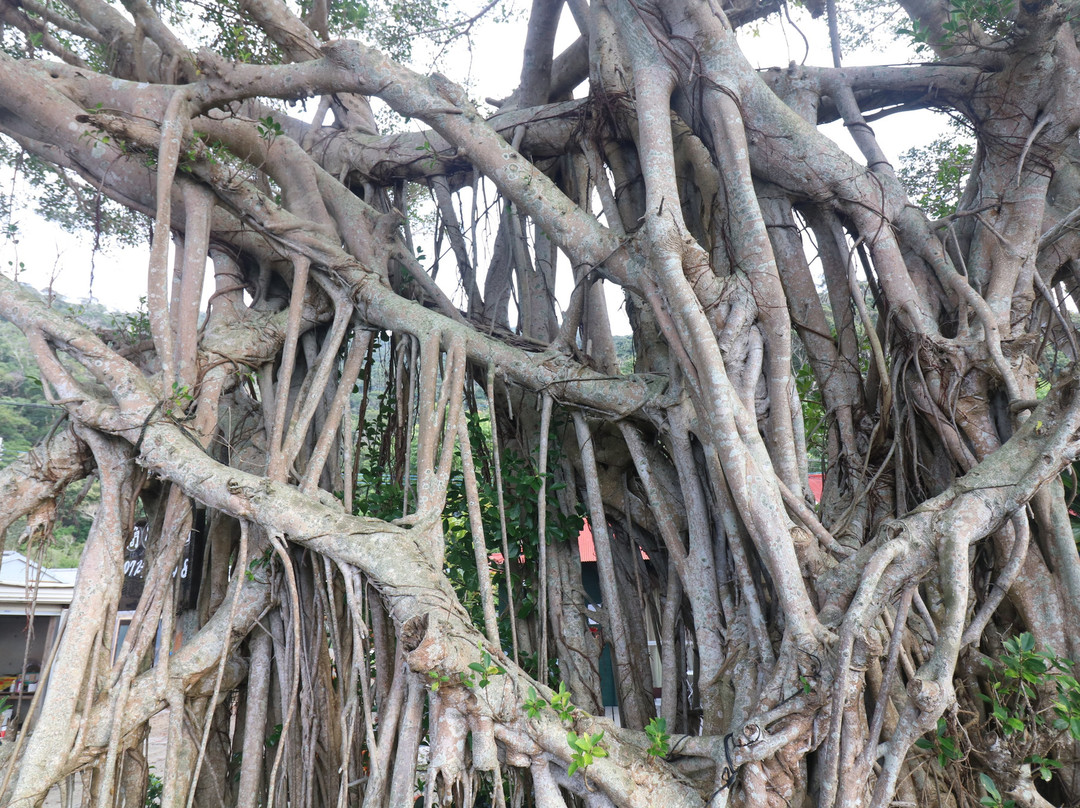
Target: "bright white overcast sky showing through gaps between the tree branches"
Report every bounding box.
[0,0,944,333]
